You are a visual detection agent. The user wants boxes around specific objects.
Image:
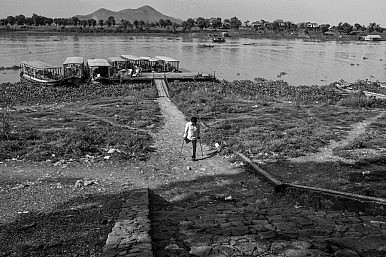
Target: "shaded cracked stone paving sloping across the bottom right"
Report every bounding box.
[150,176,386,257]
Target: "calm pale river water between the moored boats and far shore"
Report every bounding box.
[0,35,386,85]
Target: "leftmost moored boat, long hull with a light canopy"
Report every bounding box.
[20,61,63,86]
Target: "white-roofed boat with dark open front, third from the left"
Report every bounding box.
[87,59,110,83]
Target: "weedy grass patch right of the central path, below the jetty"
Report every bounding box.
[169,79,376,159]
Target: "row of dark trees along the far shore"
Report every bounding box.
[0,13,384,34]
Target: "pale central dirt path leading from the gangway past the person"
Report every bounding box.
[141,97,247,201]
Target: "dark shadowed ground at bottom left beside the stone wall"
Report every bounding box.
[0,187,137,256]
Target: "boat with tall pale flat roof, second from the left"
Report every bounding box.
[63,57,86,84]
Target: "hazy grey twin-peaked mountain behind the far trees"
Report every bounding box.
[75,5,182,23]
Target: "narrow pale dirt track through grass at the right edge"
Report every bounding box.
[290,111,386,163]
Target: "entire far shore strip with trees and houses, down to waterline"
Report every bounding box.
[0,11,385,40]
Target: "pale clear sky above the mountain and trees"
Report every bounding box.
[0,0,386,27]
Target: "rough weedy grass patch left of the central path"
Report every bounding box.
[0,83,161,161]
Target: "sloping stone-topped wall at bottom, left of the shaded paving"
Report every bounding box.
[100,189,153,257]
